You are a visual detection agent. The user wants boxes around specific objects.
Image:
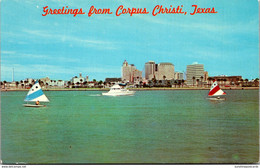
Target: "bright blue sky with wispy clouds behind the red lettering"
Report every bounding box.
[0,0,259,81]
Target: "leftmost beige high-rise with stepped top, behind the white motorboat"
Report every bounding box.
[122,60,142,82]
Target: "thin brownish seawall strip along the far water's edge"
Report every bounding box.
[0,87,259,92]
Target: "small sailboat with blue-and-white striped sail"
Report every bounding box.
[24,81,49,107]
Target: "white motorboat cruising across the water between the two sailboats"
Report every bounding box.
[102,84,135,96]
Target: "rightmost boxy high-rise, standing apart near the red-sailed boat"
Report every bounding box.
[186,63,204,85]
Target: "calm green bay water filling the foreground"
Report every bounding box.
[1,90,259,164]
